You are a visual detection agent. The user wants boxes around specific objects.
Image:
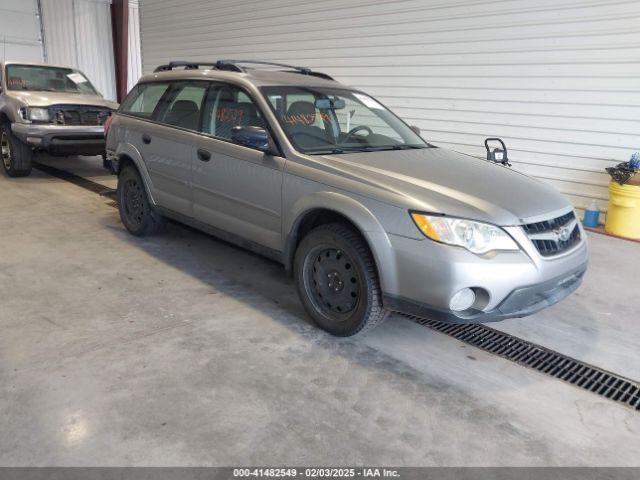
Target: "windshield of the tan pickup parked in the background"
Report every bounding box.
[6,65,98,95]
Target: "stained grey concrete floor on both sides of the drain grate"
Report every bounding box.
[0,159,640,466]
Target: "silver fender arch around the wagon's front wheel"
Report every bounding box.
[283,191,397,291]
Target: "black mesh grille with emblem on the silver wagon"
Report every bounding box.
[523,212,581,257]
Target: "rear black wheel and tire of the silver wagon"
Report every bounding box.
[117,166,166,237]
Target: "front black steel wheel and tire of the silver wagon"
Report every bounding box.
[294,223,388,337]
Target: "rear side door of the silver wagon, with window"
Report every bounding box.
[140,81,208,217]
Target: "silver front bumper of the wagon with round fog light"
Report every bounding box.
[381,227,588,323]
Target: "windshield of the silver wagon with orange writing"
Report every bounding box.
[261,86,430,154]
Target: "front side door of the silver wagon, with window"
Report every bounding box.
[193,84,285,250]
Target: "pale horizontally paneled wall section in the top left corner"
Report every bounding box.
[0,0,42,62]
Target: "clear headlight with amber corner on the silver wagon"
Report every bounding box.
[411,212,519,255]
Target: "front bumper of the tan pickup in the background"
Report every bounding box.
[11,123,105,156]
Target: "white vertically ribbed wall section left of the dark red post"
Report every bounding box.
[41,0,116,99]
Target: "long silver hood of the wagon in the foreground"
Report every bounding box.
[324,148,571,226]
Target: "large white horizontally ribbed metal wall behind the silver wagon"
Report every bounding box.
[136,0,640,215]
